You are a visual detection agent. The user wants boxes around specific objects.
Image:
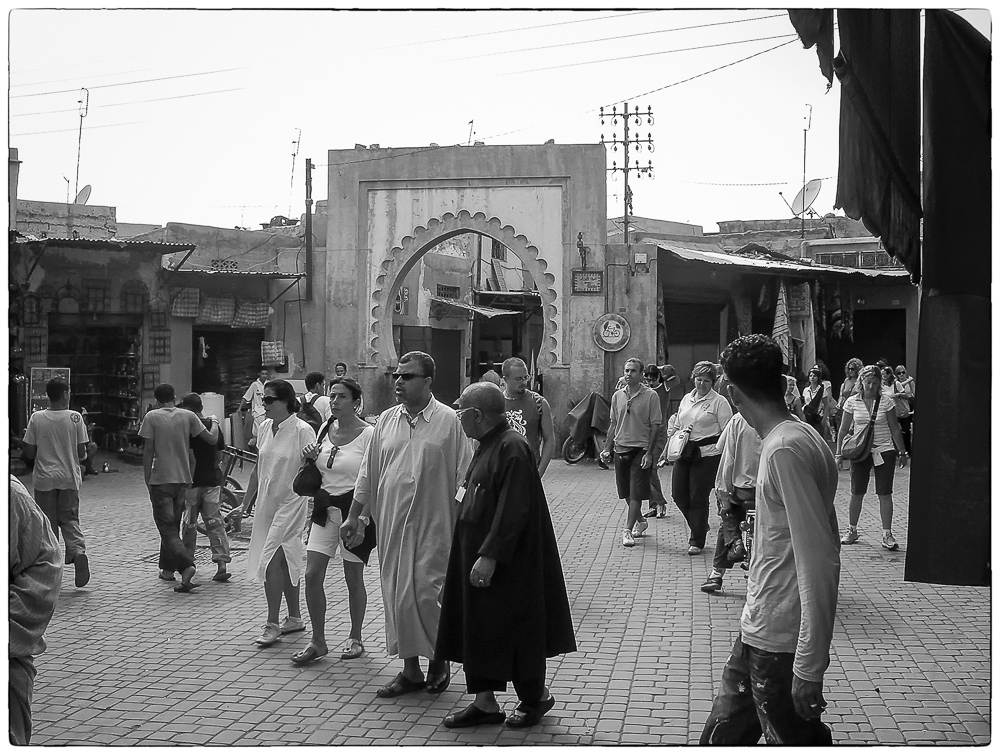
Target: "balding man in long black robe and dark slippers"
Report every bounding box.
[435,383,576,729]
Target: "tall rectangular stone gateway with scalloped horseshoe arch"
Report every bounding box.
[326,144,607,416]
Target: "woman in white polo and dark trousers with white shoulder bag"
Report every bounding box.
[659,362,733,556]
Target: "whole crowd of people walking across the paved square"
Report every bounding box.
[11,342,915,744]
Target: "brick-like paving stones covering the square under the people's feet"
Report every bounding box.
[19,452,991,745]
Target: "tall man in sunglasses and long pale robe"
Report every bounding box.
[341,351,472,697]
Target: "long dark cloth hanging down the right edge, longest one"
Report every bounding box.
[905,10,993,586]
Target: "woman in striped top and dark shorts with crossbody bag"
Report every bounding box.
[836,365,908,551]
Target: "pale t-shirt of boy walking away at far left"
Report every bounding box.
[24,409,89,490]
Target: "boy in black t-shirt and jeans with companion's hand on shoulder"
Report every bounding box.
[178,393,232,582]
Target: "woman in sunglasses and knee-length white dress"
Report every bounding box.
[246,380,316,648]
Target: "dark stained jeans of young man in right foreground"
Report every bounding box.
[700,637,833,746]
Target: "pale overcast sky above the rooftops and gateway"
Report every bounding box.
[8,8,990,231]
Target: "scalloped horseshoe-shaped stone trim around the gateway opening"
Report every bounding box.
[367,210,561,369]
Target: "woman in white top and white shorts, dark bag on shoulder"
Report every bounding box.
[292,377,375,666]
